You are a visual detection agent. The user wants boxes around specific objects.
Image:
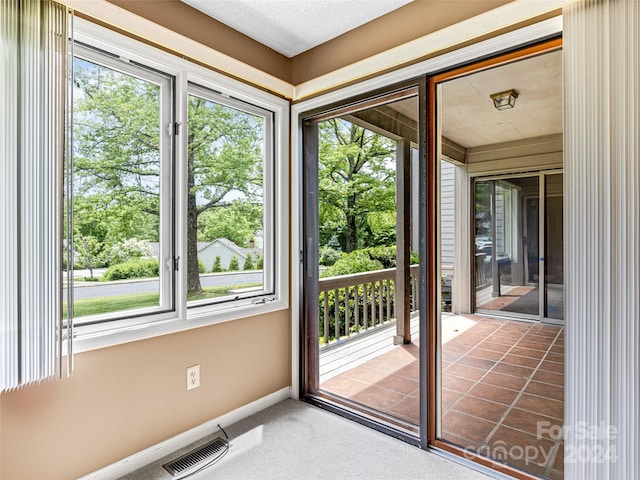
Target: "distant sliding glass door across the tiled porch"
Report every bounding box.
[473,172,564,323]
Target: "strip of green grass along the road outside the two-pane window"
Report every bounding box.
[63,283,261,318]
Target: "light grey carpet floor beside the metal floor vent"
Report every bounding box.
[121,400,498,480]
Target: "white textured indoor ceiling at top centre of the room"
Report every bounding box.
[181,0,413,57]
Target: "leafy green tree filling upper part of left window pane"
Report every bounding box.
[73,59,161,240]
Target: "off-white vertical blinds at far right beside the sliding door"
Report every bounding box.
[563,0,640,480]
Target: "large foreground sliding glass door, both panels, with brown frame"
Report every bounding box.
[300,33,564,478]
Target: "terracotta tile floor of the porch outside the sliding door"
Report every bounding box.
[321,315,564,479]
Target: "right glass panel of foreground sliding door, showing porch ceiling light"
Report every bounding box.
[429,41,564,478]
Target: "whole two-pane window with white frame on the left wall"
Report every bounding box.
[64,20,289,351]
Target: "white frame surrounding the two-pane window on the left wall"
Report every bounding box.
[73,18,289,353]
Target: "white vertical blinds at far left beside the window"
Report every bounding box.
[0,0,68,392]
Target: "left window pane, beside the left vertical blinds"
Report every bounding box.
[65,53,171,322]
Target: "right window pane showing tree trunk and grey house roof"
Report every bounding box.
[187,87,270,306]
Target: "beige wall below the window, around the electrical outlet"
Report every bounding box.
[0,311,291,480]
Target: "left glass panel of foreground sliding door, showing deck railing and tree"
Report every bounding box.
[306,88,420,435]
